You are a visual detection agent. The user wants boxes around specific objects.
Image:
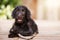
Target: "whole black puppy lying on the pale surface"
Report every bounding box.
[8,6,38,39]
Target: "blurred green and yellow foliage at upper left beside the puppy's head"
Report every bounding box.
[0,0,22,19]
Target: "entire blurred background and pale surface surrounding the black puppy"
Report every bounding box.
[0,0,60,40]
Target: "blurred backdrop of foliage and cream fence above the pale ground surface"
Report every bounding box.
[0,0,60,21]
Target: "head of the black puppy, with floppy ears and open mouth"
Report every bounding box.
[12,6,30,23]
